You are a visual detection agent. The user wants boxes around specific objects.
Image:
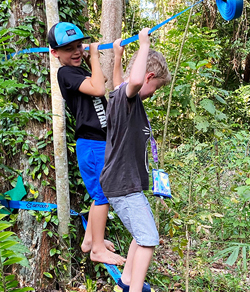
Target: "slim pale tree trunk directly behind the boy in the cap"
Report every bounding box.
[45,0,71,290]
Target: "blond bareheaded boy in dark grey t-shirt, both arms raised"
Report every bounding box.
[100,28,171,292]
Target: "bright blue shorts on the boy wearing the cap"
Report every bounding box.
[76,138,108,205]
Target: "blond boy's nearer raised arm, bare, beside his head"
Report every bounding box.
[126,28,150,98]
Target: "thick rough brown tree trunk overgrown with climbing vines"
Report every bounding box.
[9,0,56,290]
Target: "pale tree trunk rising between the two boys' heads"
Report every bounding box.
[100,0,123,91]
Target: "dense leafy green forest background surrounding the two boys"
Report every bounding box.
[0,0,250,292]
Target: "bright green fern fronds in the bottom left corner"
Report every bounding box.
[0,206,35,292]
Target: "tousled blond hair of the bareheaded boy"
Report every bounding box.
[124,49,171,85]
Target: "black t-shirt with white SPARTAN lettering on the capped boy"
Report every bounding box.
[57,66,107,141]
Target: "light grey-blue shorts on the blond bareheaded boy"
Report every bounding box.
[108,192,159,246]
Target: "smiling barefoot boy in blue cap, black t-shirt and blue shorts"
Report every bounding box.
[48,22,125,265]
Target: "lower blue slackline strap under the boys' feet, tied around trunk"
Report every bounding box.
[0,200,121,283]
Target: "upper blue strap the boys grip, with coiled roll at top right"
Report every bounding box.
[2,0,243,61]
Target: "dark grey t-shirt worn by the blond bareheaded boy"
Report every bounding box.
[100,85,150,198]
